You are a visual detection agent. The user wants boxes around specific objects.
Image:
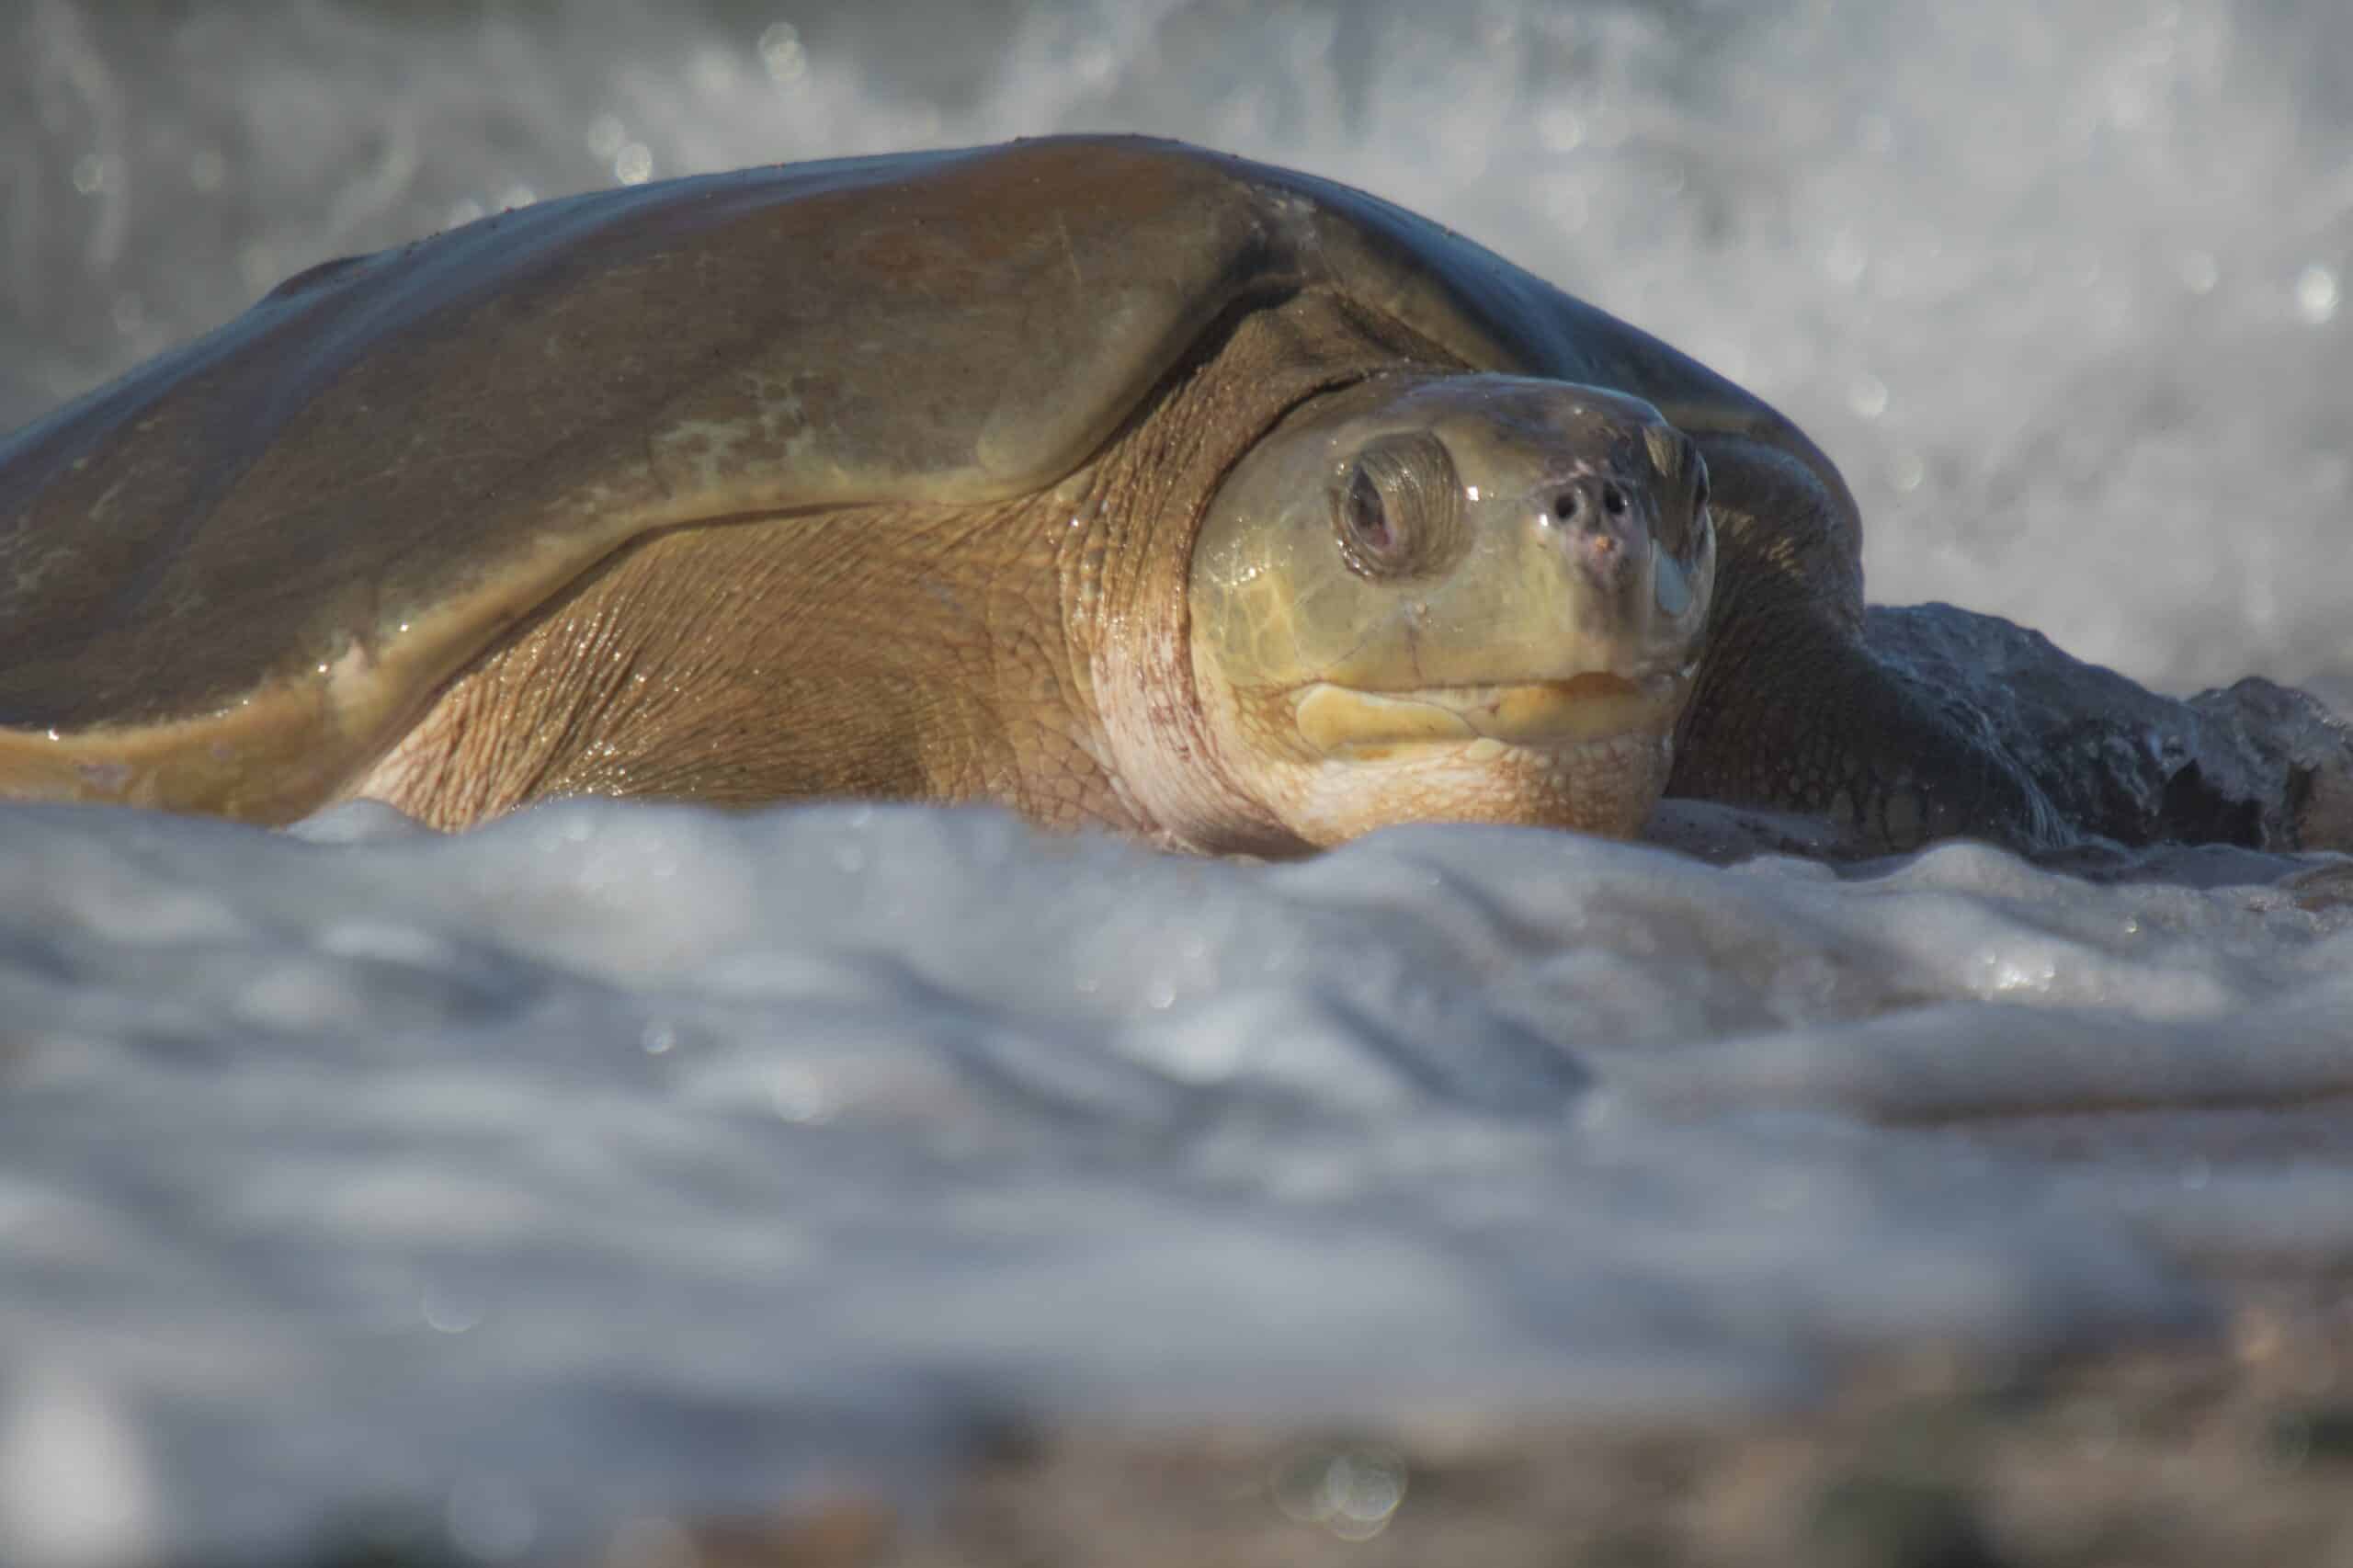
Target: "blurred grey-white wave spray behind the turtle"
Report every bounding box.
[0,0,2353,709]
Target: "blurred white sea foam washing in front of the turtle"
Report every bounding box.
[0,802,2353,1561]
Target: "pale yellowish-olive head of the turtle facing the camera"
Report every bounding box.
[1188,374,1715,846]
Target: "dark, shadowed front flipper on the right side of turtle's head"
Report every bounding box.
[1665,433,2075,850]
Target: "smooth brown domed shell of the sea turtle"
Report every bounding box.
[0,137,1836,817]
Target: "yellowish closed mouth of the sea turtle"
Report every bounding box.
[1291,671,1689,763]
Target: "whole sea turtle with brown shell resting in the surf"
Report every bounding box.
[0,137,2098,855]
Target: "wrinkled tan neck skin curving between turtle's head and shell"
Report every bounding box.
[1063,292,1459,857]
